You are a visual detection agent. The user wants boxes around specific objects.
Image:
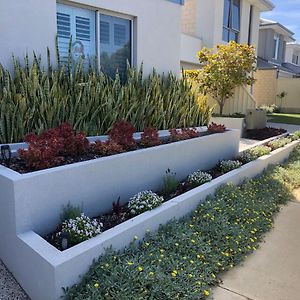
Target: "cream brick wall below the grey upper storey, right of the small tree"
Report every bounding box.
[253,70,278,107]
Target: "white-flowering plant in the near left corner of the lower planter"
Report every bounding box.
[57,213,103,245]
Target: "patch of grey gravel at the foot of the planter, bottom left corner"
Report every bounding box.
[0,260,30,300]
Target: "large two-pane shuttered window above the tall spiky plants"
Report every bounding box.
[57,4,132,79]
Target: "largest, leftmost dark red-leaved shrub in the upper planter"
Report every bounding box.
[18,123,89,171]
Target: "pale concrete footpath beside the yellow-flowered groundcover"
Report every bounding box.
[212,190,300,300]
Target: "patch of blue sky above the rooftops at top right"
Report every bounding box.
[261,0,300,42]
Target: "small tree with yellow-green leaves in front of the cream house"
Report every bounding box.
[187,42,256,115]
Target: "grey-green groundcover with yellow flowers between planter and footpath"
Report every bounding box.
[66,147,300,300]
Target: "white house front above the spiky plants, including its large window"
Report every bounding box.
[0,0,183,74]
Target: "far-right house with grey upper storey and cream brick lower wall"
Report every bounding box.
[254,19,300,112]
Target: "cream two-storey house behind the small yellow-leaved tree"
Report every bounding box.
[180,0,274,114]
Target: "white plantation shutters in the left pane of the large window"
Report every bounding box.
[57,4,96,63]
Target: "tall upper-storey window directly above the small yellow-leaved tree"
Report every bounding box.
[223,0,240,42]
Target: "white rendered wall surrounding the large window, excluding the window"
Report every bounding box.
[0,0,182,74]
